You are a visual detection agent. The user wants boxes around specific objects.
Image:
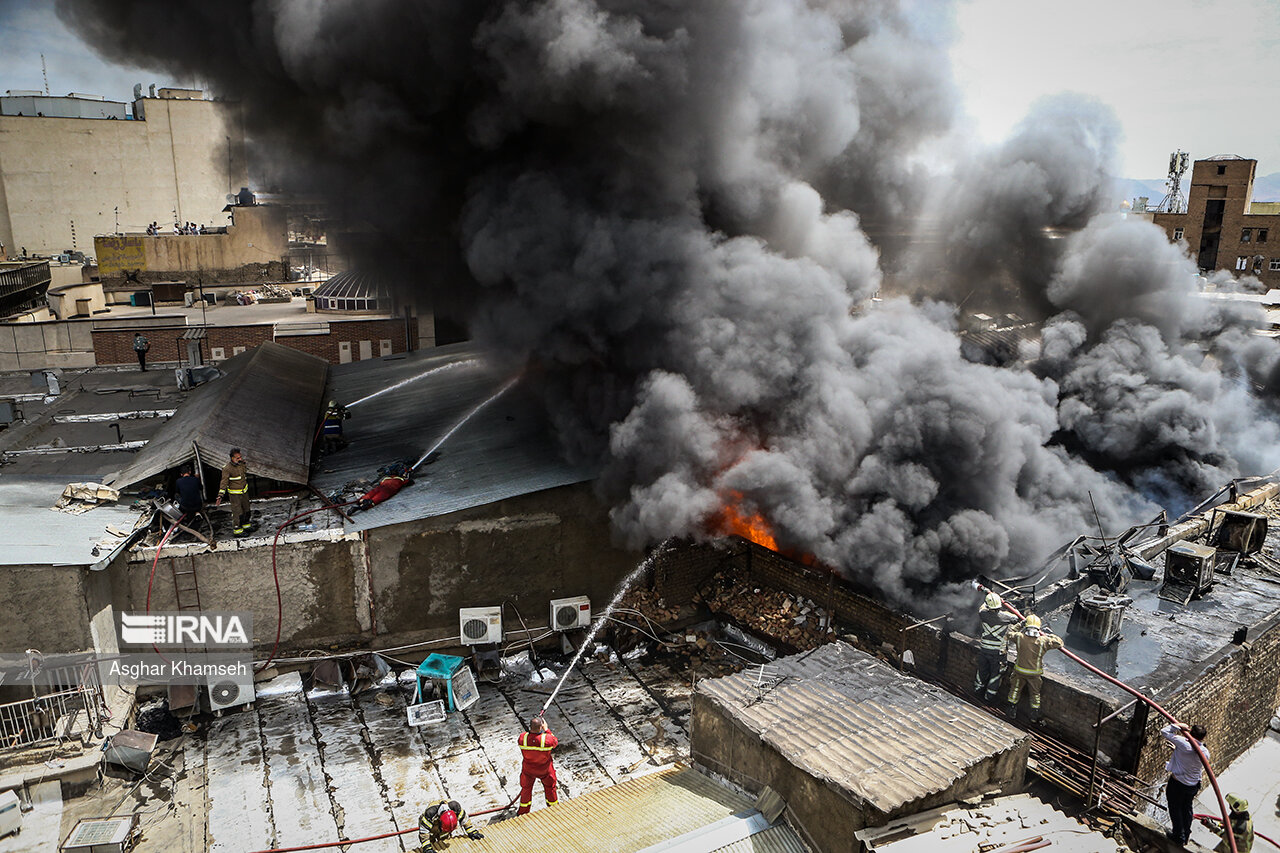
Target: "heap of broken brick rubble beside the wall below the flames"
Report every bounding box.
[694,573,829,651]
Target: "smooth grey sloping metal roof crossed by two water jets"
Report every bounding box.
[312,343,595,532]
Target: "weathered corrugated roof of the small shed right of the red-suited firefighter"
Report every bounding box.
[698,643,1027,812]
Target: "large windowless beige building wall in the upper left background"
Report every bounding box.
[0,88,247,254]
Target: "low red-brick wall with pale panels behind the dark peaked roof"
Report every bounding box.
[93,318,417,365]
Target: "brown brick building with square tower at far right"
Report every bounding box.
[1152,155,1280,287]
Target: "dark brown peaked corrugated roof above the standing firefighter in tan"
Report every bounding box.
[111,341,329,488]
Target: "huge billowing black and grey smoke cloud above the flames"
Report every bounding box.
[59,0,1276,611]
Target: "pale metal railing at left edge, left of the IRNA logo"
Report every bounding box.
[0,663,105,751]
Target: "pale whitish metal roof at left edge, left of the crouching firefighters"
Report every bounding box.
[0,475,138,566]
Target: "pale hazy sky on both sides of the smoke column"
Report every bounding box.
[0,0,1280,178]
